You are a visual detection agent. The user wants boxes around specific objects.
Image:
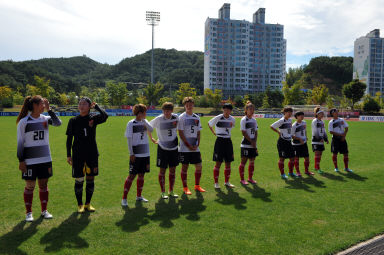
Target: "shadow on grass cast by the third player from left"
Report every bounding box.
[116,202,149,232]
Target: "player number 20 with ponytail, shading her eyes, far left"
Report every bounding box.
[16,96,61,222]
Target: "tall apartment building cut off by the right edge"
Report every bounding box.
[353,29,384,96]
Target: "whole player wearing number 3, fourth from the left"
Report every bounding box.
[148,102,179,199]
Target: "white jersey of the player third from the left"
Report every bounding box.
[125,119,152,158]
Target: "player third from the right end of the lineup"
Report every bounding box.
[292,112,314,177]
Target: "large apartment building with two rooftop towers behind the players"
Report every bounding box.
[204,3,286,98]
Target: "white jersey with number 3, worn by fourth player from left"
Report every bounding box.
[149,113,179,150]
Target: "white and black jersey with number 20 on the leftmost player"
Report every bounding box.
[17,111,61,165]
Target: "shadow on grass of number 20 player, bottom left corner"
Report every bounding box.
[0,217,43,255]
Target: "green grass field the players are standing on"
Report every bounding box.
[0,117,384,254]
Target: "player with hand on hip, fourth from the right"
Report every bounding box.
[271,107,297,179]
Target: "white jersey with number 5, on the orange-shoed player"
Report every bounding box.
[178,112,202,152]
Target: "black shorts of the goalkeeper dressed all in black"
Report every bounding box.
[72,156,99,178]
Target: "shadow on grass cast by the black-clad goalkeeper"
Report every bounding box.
[40,212,91,252]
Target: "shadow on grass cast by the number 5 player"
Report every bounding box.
[178,191,207,221]
